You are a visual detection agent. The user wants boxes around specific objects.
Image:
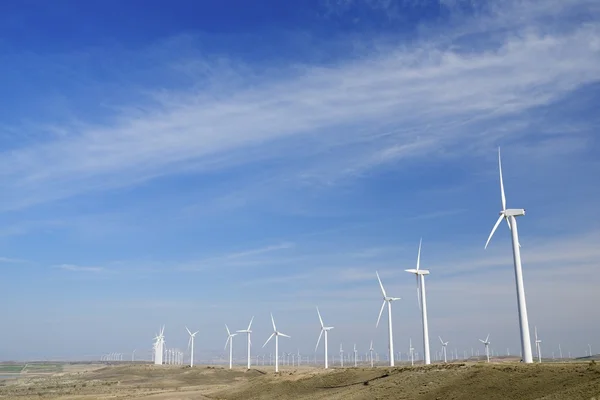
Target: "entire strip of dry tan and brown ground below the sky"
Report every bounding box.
[0,362,600,400]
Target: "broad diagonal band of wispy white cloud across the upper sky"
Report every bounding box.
[0,3,600,209]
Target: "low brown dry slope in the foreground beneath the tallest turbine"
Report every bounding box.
[209,364,600,400]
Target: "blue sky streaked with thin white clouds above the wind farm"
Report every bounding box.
[0,0,600,360]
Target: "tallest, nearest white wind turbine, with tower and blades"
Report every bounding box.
[485,148,533,364]
